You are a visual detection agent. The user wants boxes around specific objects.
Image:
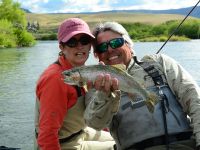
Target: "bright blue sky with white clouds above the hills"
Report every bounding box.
[14,0,199,13]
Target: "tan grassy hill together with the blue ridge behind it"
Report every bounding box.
[24,6,200,31]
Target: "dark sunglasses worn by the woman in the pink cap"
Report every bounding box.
[63,35,91,48]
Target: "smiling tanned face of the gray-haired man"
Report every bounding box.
[96,31,132,66]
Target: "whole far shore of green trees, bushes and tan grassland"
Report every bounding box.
[0,0,200,48]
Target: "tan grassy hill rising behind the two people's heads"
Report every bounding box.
[26,12,194,31]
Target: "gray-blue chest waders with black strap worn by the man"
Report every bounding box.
[110,60,191,149]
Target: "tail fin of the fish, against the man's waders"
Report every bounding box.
[145,93,159,113]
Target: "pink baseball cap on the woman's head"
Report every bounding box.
[57,18,95,43]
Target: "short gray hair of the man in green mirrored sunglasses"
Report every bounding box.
[93,22,133,51]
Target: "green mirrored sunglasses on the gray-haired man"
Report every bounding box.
[96,38,125,53]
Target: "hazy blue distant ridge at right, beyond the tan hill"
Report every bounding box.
[94,6,200,18]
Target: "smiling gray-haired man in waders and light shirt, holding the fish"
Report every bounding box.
[85,22,200,150]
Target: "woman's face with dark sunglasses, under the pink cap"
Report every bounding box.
[60,33,92,67]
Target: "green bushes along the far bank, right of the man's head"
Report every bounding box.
[122,19,200,41]
